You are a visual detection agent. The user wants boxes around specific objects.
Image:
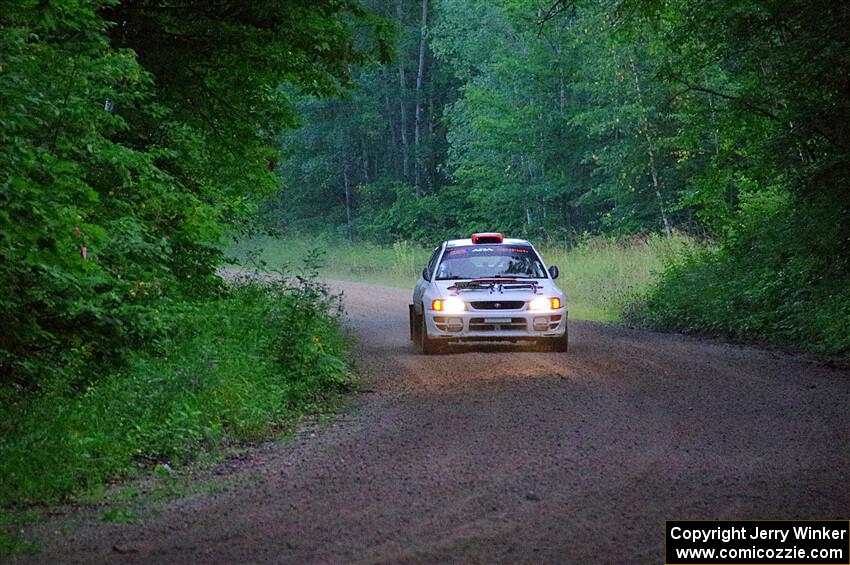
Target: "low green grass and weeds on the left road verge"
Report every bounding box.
[0,276,352,555]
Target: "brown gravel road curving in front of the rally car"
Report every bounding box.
[14,283,850,563]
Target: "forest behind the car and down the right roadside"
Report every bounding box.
[274,0,850,352]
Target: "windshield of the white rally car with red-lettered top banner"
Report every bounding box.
[437,244,546,281]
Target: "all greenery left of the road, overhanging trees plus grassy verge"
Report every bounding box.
[0,0,389,551]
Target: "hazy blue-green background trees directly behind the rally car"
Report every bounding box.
[272,0,691,242]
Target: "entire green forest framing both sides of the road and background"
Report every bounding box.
[0,0,850,549]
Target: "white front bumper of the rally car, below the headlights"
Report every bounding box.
[425,308,567,341]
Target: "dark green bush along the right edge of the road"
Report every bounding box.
[626,197,850,354]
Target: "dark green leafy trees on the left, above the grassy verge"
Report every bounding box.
[0,0,388,390]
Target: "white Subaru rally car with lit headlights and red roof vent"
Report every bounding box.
[409,233,568,354]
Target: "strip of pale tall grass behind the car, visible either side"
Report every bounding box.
[229,235,692,322]
